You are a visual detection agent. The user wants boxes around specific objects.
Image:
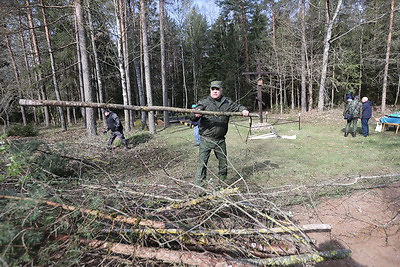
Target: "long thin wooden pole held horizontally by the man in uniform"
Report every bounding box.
[19,99,258,117]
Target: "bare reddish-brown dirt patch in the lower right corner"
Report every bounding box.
[295,182,400,267]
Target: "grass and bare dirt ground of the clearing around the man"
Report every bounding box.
[0,107,400,266]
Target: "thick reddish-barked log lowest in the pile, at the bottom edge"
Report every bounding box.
[81,239,254,267]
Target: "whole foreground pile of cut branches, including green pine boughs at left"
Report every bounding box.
[0,137,350,266]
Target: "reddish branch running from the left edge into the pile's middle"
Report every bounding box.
[0,195,165,228]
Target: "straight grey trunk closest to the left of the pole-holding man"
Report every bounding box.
[159,0,170,127]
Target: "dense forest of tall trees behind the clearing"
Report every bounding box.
[0,0,400,134]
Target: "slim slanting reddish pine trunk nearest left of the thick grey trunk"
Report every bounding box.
[40,0,67,131]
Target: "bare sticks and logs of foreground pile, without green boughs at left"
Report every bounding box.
[0,183,350,266]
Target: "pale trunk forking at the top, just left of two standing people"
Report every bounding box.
[318,0,343,112]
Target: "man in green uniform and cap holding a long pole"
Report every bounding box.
[191,81,249,186]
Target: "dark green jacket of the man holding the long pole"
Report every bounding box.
[191,96,247,140]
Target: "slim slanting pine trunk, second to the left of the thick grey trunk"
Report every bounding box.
[25,0,50,127]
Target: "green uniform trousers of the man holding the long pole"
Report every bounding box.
[194,136,228,186]
